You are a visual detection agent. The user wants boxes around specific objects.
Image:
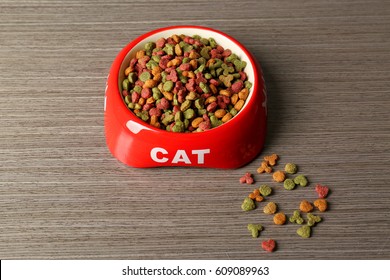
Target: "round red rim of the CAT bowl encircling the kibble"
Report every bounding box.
[114,25,261,138]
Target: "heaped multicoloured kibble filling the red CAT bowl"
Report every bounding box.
[122,35,252,132]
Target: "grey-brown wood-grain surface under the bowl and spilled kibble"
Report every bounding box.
[0,0,390,259]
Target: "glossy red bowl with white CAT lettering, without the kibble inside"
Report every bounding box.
[104,26,267,168]
